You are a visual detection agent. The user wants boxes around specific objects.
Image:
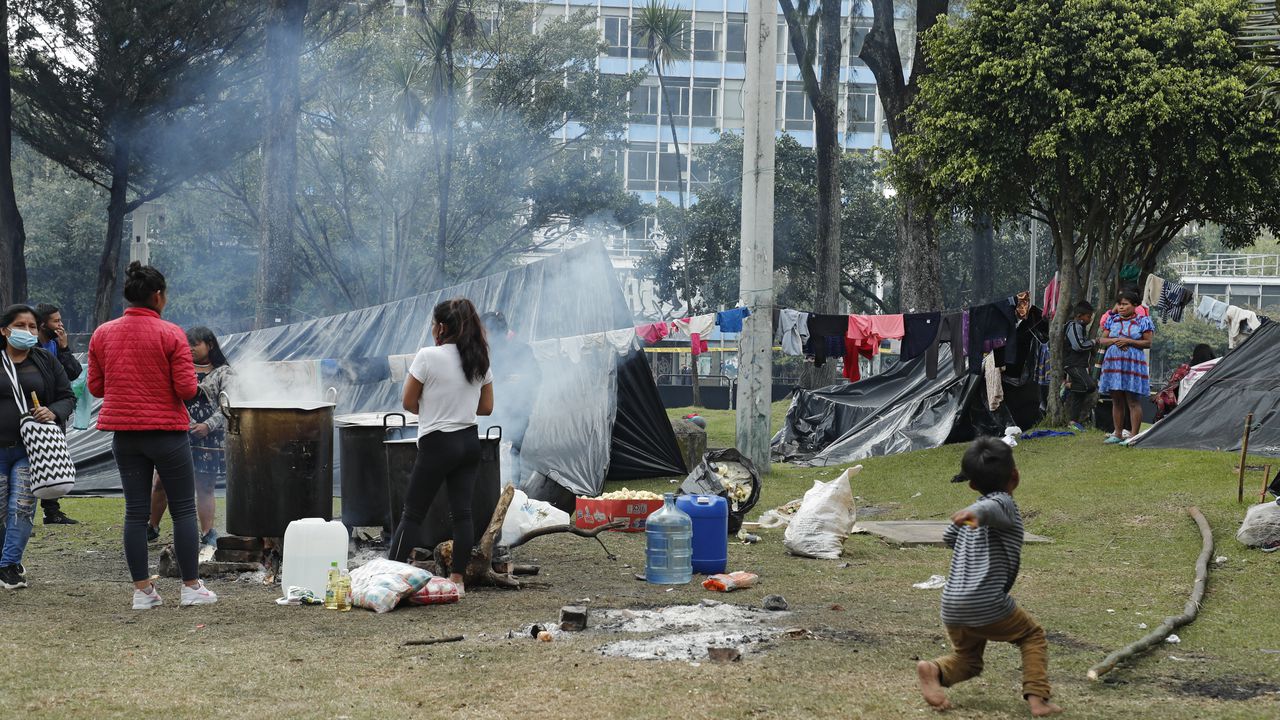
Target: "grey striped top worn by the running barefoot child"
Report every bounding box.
[942,492,1023,628]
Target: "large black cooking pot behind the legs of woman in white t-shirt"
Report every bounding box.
[383,427,502,548]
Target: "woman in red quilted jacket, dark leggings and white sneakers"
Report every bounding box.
[88,261,218,610]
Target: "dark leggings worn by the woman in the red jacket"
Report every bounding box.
[111,430,200,583]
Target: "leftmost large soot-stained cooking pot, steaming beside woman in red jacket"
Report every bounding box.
[219,393,337,538]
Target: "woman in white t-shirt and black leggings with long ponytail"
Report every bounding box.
[389,297,493,593]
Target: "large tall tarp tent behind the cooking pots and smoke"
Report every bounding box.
[68,242,684,492]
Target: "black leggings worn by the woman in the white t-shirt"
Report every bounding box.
[388,427,480,574]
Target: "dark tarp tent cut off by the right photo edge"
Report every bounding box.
[1129,323,1280,457]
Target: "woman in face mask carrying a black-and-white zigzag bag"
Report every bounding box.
[0,305,76,589]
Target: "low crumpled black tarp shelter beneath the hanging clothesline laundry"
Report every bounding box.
[773,345,1041,465]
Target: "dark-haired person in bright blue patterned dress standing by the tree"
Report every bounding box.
[1098,290,1156,443]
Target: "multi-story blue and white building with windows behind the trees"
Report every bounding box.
[540,0,896,314]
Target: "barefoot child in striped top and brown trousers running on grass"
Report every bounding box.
[915,437,1062,717]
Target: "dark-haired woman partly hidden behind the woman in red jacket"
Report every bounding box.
[147,325,234,546]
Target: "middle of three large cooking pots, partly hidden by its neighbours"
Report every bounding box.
[333,413,417,533]
